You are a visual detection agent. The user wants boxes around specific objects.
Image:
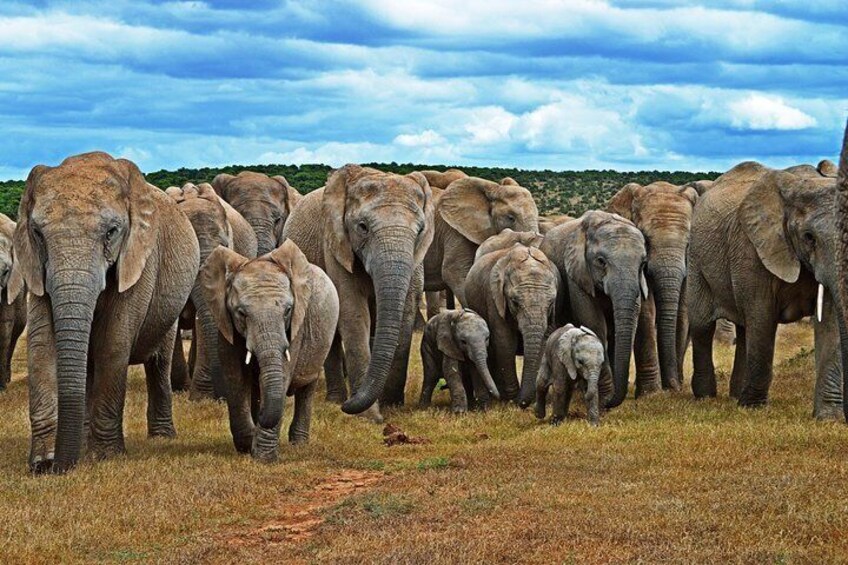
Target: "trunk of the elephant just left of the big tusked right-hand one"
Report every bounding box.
[653,266,685,390]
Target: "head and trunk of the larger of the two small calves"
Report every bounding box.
[436,308,500,399]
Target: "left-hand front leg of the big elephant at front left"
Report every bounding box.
[27,294,58,473]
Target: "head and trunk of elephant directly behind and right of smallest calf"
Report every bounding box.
[542,211,648,408]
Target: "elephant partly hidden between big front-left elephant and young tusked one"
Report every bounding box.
[165,183,257,400]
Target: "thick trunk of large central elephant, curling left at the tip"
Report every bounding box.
[342,228,415,414]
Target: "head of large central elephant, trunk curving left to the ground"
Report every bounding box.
[323,165,433,414]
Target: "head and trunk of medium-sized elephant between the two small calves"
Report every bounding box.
[489,245,560,407]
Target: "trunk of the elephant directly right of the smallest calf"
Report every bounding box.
[606,281,641,408]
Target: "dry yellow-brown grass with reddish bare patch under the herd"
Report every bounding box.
[0,325,848,563]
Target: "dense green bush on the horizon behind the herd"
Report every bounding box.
[0,163,720,218]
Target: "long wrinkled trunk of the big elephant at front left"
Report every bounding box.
[48,269,99,473]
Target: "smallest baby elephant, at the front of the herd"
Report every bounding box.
[536,324,604,426]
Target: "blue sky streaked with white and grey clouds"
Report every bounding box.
[0,0,848,179]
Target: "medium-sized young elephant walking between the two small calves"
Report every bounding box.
[465,244,560,408]
